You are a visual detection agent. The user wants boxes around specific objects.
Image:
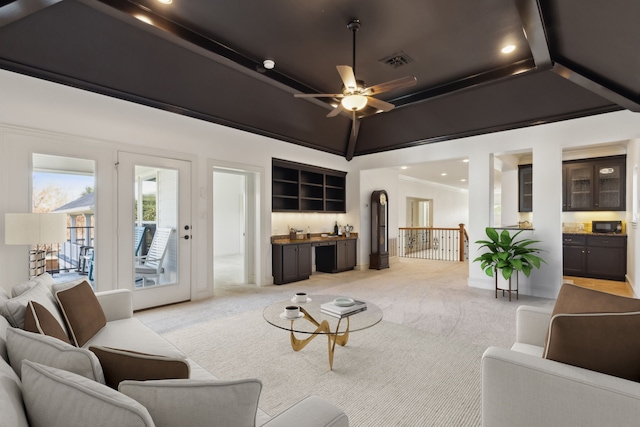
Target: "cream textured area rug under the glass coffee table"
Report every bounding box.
[164,310,485,427]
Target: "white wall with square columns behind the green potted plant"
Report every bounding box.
[352,111,640,298]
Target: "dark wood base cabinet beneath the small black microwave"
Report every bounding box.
[562,234,627,281]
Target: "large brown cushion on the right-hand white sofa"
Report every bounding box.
[543,284,640,381]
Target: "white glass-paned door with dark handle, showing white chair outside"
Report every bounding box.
[118,152,192,310]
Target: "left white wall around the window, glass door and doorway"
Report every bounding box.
[0,71,350,298]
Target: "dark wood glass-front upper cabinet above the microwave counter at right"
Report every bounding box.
[562,156,626,211]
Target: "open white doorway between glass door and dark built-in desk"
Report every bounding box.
[212,166,260,288]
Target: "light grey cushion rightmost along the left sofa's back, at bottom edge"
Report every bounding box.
[118,379,262,427]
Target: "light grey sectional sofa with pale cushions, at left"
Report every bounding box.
[0,278,348,427]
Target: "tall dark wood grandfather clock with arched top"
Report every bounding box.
[369,190,389,270]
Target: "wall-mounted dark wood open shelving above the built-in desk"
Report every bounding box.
[271,159,347,212]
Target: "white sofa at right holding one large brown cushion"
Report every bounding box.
[482,306,640,427]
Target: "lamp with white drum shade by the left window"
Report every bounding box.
[4,213,67,278]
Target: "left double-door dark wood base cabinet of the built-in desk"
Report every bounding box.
[272,243,311,285]
